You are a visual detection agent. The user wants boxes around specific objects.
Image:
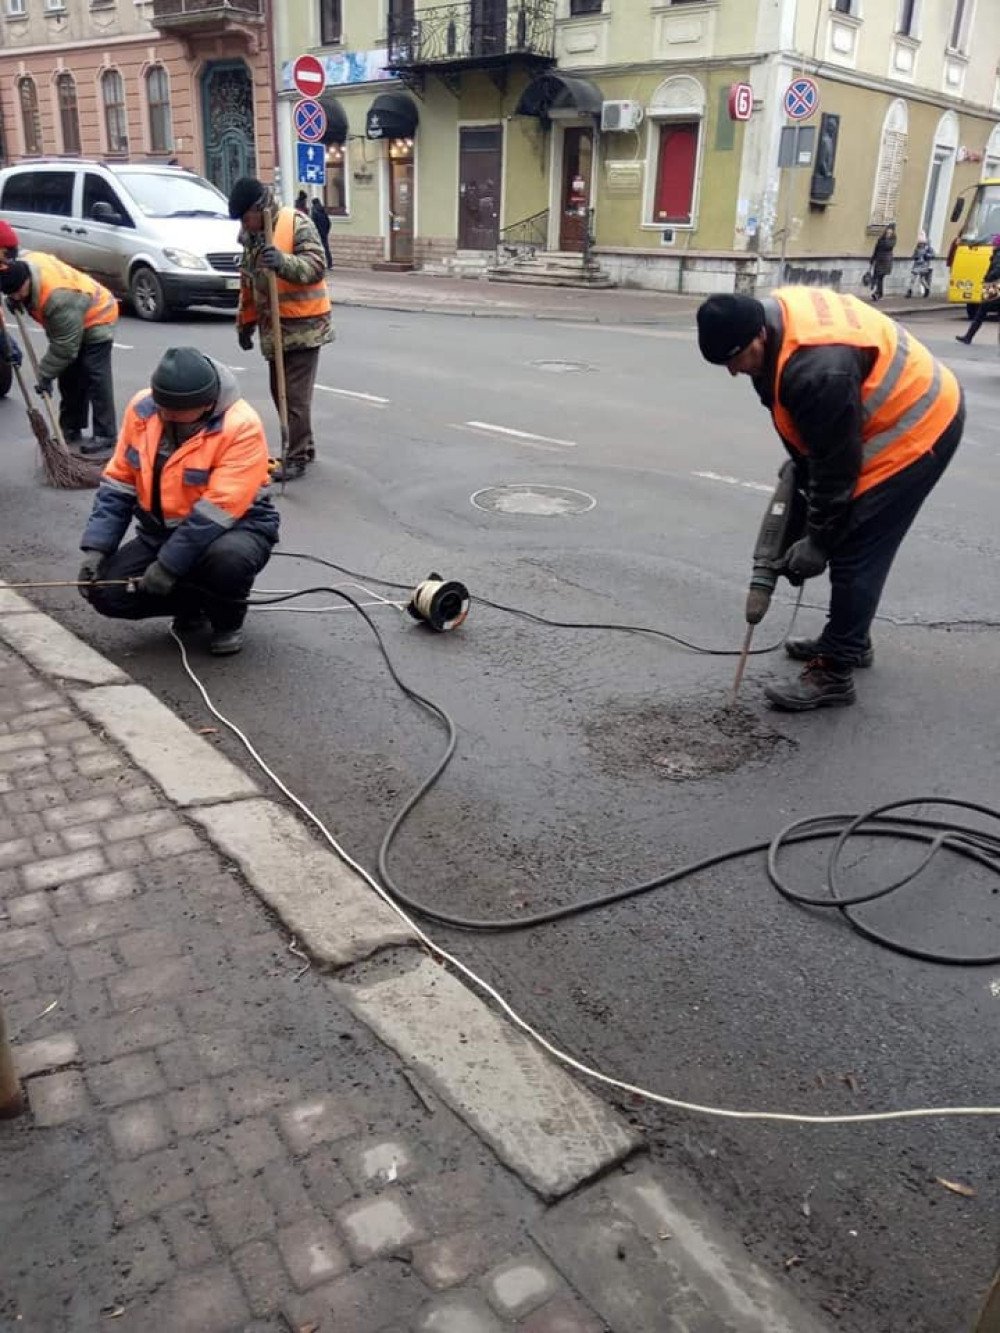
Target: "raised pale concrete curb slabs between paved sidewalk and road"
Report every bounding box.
[0,589,639,1198]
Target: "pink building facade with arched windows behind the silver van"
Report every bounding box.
[0,0,276,191]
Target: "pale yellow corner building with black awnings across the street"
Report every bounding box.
[276,0,1000,292]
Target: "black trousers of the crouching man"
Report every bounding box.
[89,528,272,631]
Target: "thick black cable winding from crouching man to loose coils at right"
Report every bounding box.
[241,578,1000,966]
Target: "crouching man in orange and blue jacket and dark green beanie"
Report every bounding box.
[80,347,279,656]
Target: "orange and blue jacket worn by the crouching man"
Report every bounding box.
[80,361,280,579]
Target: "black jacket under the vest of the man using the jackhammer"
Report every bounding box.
[753,300,876,553]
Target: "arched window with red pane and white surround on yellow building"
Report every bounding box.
[645,75,705,228]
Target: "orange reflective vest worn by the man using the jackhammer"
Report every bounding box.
[771,287,961,496]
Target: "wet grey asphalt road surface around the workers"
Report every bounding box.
[0,309,1000,1333]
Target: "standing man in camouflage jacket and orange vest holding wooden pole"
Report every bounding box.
[229,176,333,481]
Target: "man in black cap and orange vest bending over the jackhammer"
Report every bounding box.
[697,287,965,712]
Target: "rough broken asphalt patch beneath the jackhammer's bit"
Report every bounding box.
[587,697,797,782]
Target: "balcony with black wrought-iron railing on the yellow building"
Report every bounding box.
[387,0,556,75]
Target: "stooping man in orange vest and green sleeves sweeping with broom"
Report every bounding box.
[0,251,119,455]
